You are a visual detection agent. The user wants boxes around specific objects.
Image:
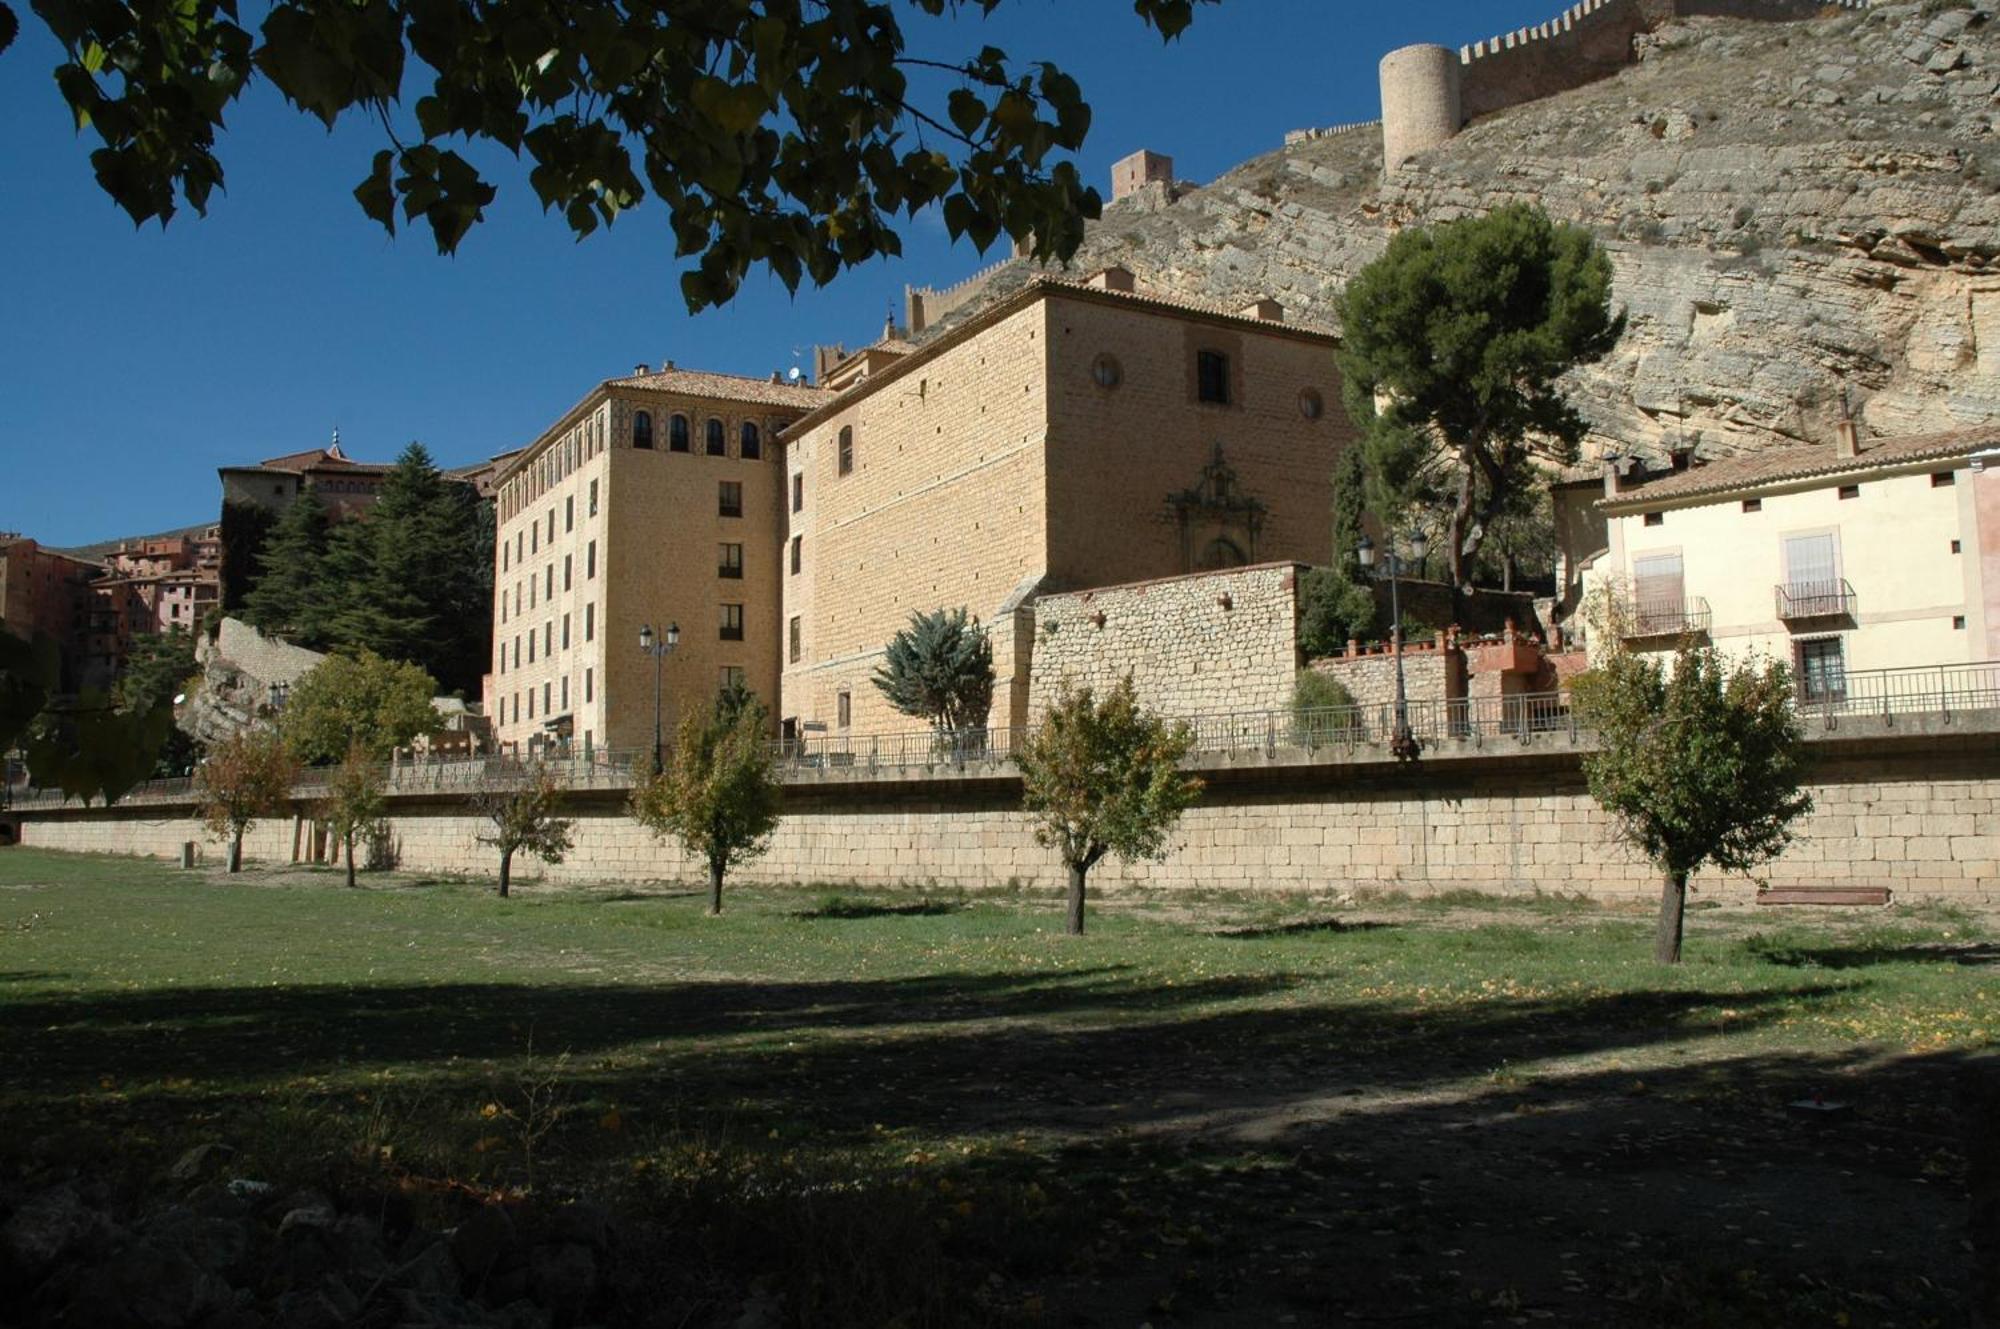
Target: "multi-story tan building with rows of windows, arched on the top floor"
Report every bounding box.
[486,364,830,749]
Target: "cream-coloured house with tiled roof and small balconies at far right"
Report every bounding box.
[1576,424,2000,701]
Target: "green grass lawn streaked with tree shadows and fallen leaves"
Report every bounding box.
[0,849,2000,1327]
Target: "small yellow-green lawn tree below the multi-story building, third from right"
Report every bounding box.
[632,697,778,915]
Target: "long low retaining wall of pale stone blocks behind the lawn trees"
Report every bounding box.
[22,749,2000,907]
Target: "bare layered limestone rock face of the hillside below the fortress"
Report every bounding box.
[932,4,2000,466]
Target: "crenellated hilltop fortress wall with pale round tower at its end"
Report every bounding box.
[1384,0,1868,170]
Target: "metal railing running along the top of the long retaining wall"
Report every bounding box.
[6,660,2000,809]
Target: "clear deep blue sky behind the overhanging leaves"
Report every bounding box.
[0,0,1562,544]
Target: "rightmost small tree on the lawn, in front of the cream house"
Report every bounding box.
[1572,640,1812,965]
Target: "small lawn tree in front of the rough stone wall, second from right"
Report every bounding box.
[1014,677,1202,937]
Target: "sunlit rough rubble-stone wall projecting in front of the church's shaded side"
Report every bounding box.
[1028,562,1300,717]
